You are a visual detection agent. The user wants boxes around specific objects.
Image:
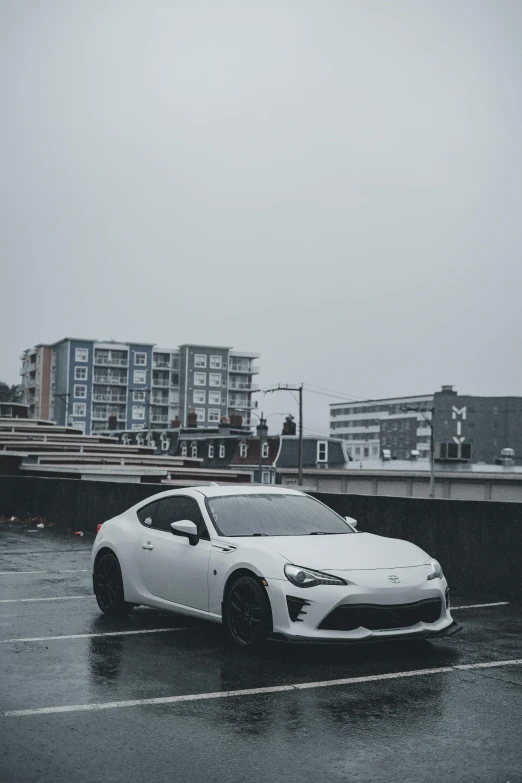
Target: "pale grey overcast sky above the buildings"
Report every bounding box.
[0,0,522,432]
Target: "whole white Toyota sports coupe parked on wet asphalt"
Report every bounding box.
[92,485,460,648]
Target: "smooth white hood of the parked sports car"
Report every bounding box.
[261,533,430,571]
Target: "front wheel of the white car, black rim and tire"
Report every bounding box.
[223,575,272,652]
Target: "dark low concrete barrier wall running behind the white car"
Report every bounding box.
[0,476,522,601]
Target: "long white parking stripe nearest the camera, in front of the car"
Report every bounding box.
[4,658,522,718]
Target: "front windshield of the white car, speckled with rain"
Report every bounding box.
[207,494,354,536]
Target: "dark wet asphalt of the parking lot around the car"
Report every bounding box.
[0,525,522,783]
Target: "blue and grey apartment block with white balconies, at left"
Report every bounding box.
[21,337,259,434]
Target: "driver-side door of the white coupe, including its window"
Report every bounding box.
[140,495,210,611]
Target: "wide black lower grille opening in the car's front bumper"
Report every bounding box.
[319,598,442,631]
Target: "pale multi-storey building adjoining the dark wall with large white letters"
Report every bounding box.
[330,394,434,462]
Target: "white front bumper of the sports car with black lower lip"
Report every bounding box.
[267,568,461,643]
